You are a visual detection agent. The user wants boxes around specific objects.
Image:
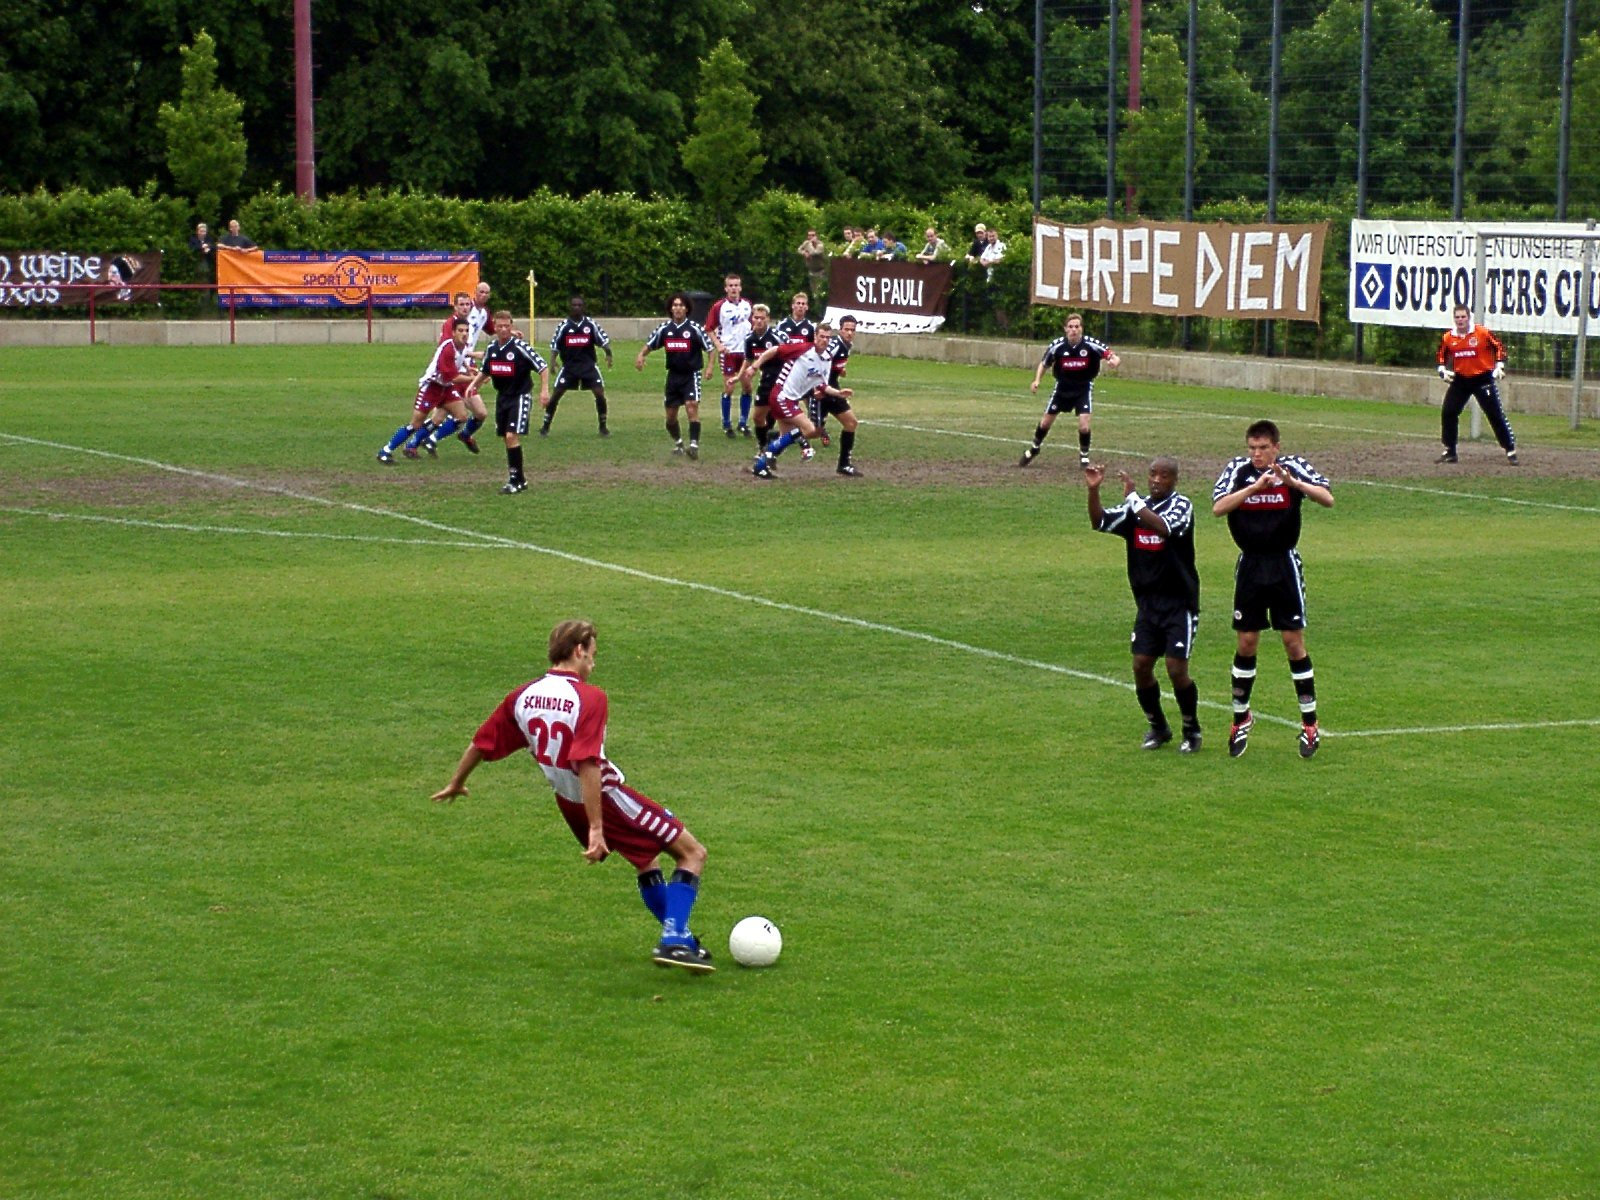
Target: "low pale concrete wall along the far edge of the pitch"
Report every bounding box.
[0,317,1600,419]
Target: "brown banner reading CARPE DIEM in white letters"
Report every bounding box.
[1032,218,1328,322]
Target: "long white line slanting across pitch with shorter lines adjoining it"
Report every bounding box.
[0,434,1600,738]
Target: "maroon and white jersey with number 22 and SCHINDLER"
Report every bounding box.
[472,670,622,805]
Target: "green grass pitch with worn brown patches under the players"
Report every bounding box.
[0,346,1600,1200]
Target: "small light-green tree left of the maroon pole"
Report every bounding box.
[157,29,245,219]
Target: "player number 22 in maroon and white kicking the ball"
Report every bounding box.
[434,621,717,971]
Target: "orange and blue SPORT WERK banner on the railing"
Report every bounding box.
[216,246,478,309]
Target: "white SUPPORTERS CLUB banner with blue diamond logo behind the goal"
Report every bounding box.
[1349,221,1600,336]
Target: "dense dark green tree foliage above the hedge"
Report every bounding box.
[0,0,1600,216]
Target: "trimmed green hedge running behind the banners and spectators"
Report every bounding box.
[0,186,1574,363]
